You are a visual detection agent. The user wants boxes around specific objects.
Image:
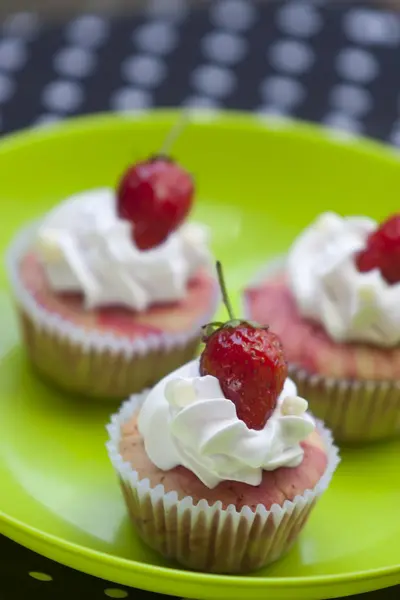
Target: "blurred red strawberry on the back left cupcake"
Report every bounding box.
[117,156,194,250]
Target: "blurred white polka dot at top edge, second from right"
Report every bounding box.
[277,0,322,37]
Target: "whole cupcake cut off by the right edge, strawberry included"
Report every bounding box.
[244,212,400,443]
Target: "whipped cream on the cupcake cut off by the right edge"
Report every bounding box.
[287,212,400,347]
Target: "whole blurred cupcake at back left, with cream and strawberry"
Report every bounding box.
[7,157,219,400]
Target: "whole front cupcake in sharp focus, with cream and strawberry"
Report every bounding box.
[107,270,339,573]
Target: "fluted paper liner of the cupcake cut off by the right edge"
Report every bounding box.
[244,257,400,444]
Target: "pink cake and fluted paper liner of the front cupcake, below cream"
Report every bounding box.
[107,372,339,574]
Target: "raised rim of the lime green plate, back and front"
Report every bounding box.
[0,108,400,590]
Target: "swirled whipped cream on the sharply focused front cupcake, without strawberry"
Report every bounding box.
[139,360,315,488]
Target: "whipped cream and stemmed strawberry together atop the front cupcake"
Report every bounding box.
[138,263,315,488]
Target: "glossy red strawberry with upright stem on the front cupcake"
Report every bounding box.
[200,263,287,429]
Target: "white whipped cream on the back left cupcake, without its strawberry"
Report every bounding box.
[35,188,210,311]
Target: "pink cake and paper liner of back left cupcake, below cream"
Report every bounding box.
[17,252,219,399]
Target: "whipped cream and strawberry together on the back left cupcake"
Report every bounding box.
[35,152,210,311]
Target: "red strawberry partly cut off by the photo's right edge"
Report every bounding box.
[356,214,400,284]
